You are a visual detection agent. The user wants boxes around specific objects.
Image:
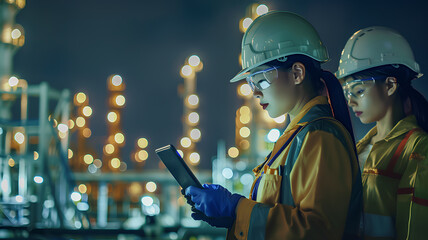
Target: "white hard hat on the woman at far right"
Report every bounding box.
[335,26,422,78]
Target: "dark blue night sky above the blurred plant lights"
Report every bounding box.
[14,0,428,168]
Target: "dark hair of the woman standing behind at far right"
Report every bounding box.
[352,64,428,132]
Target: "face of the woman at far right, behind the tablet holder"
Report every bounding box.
[342,77,389,123]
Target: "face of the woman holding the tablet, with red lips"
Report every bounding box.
[247,65,296,118]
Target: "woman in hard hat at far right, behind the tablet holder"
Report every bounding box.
[336,27,428,239]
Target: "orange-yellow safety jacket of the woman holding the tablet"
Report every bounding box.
[227,96,362,240]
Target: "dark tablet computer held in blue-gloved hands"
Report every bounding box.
[155,145,202,189]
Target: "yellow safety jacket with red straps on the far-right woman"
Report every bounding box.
[357,115,428,239]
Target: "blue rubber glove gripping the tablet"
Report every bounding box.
[185,184,243,219]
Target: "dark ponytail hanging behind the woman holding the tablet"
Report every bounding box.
[321,70,355,145]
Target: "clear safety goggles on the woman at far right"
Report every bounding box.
[342,77,384,101]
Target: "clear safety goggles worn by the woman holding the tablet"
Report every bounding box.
[246,67,280,92]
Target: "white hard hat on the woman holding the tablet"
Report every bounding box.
[230,11,328,82]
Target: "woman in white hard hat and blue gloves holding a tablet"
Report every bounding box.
[185,12,362,239]
